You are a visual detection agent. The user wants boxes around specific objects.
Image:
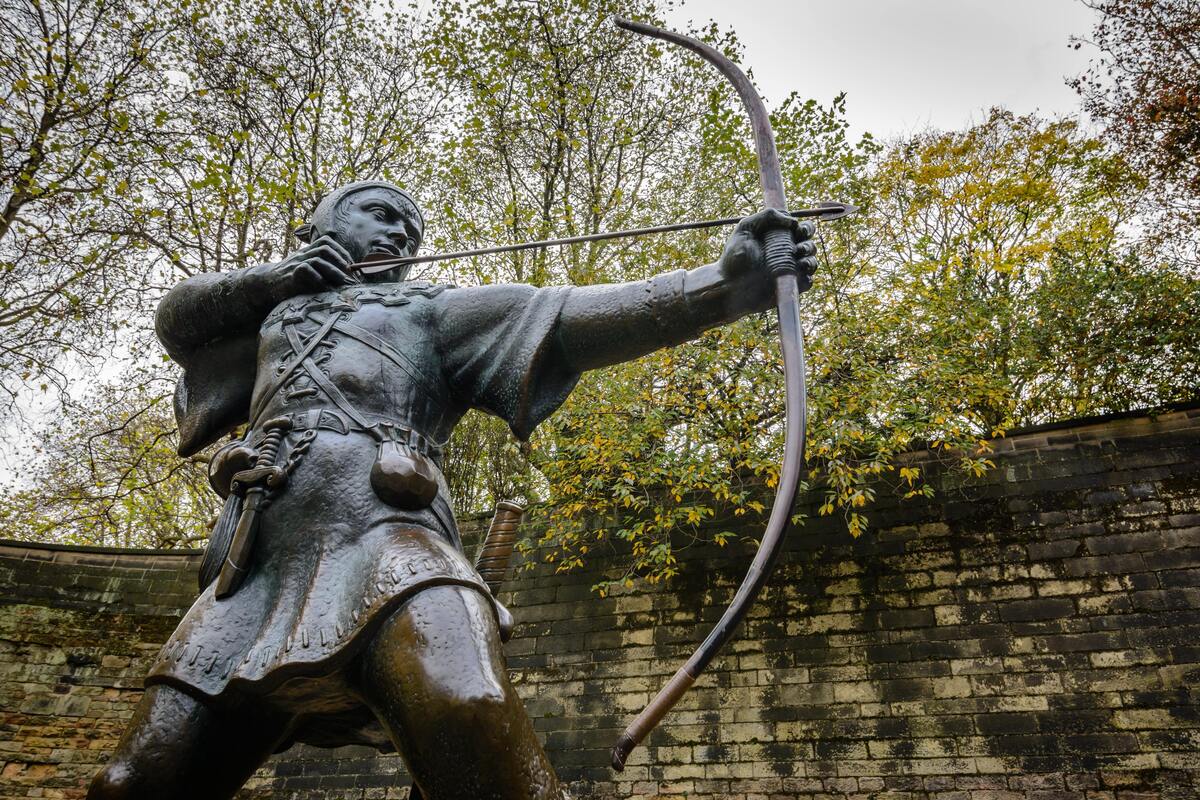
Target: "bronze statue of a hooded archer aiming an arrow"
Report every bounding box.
[88,14,836,800]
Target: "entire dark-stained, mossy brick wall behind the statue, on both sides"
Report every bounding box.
[0,409,1200,800]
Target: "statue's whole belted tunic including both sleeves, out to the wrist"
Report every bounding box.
[146,260,705,748]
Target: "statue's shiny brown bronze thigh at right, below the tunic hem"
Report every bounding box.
[362,587,563,800]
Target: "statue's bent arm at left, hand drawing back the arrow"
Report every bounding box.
[155,236,354,366]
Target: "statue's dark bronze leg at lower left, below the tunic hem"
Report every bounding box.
[88,685,287,800]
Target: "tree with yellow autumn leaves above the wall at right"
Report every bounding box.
[870,110,1200,437]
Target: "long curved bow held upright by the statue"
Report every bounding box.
[612,18,808,771]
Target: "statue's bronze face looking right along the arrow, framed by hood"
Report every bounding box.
[334,188,421,279]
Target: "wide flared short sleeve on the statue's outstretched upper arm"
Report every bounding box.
[437,284,580,441]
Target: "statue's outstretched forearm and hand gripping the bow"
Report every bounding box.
[558,211,816,372]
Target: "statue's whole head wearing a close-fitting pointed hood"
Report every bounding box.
[296,181,425,282]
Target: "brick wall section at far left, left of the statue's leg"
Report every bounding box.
[0,542,199,800]
